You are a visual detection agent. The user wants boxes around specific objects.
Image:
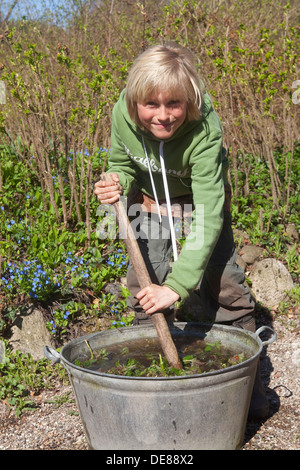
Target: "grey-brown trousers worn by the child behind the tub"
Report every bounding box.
[127,212,255,324]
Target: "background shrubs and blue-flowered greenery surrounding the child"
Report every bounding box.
[0,0,300,341]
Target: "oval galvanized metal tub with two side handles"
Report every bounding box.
[45,323,276,450]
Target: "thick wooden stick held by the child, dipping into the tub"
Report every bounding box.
[101,173,182,369]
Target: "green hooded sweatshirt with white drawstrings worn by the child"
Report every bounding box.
[108,90,228,300]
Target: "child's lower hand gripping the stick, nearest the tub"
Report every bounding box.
[136,284,180,315]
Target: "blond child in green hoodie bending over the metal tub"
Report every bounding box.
[95,43,268,415]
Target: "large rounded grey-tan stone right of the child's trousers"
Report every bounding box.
[249,258,294,308]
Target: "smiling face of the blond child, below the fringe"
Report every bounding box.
[137,92,187,140]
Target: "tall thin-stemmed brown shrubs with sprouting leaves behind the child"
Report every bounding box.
[0,0,299,231]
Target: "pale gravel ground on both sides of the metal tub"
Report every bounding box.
[0,319,300,450]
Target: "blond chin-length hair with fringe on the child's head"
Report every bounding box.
[126,43,204,126]
